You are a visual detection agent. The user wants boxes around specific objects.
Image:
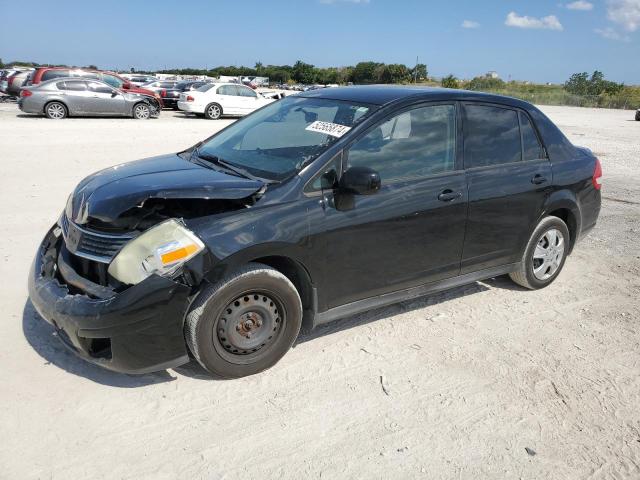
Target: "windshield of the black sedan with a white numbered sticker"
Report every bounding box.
[198,96,373,181]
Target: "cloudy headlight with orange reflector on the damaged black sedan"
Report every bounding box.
[108,220,204,285]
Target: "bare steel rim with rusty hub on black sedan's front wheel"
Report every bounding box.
[215,291,285,359]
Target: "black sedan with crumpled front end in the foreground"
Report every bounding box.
[29,87,601,378]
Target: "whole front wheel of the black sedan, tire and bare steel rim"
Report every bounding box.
[185,263,302,378]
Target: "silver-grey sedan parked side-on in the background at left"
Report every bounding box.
[18,78,160,119]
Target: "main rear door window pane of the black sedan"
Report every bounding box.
[464,105,522,168]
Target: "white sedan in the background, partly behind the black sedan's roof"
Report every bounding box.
[178,83,275,120]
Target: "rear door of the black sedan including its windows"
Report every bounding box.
[461,103,552,274]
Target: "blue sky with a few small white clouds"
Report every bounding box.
[0,0,640,84]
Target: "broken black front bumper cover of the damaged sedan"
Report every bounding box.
[29,227,190,373]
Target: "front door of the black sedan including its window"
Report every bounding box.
[311,103,467,310]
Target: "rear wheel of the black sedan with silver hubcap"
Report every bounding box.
[509,217,571,290]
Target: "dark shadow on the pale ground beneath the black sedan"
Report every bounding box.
[22,276,526,388]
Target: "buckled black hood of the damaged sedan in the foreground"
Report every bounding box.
[71,154,264,228]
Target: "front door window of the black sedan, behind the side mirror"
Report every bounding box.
[346,105,456,184]
